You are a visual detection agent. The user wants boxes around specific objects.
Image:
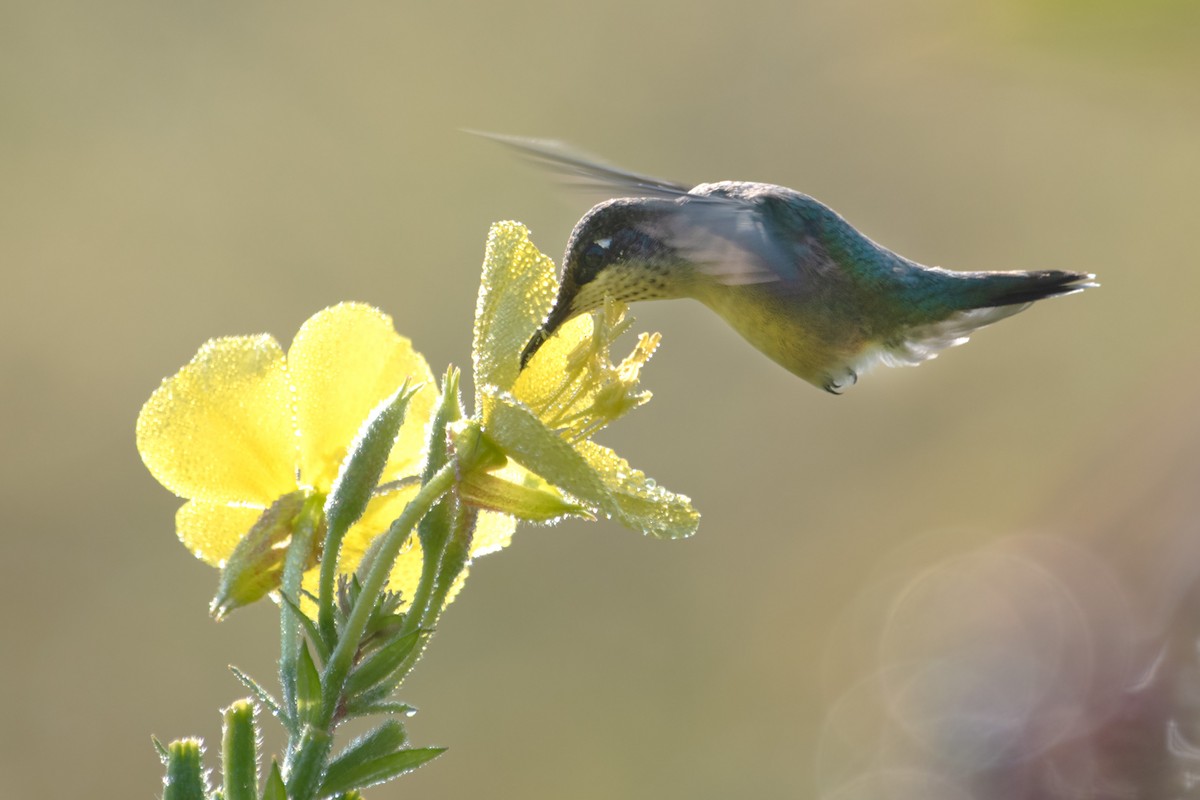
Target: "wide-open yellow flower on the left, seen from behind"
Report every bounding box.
[137,303,446,618]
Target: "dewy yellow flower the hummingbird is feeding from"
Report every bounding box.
[465,222,700,537]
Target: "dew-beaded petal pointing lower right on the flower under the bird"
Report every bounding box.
[576,440,700,539]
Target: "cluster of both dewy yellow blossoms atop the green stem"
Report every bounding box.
[137,223,698,615]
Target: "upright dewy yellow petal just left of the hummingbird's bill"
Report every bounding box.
[473,222,558,408]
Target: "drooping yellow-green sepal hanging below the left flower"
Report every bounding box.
[209,489,317,620]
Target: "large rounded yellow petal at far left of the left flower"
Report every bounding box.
[137,335,296,507]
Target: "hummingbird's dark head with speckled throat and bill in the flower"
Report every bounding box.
[521,198,682,367]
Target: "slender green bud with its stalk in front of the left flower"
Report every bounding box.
[317,380,419,649]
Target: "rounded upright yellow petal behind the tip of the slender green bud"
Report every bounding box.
[288,302,437,491]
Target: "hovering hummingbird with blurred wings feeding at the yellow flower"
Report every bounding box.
[484,134,1097,395]
